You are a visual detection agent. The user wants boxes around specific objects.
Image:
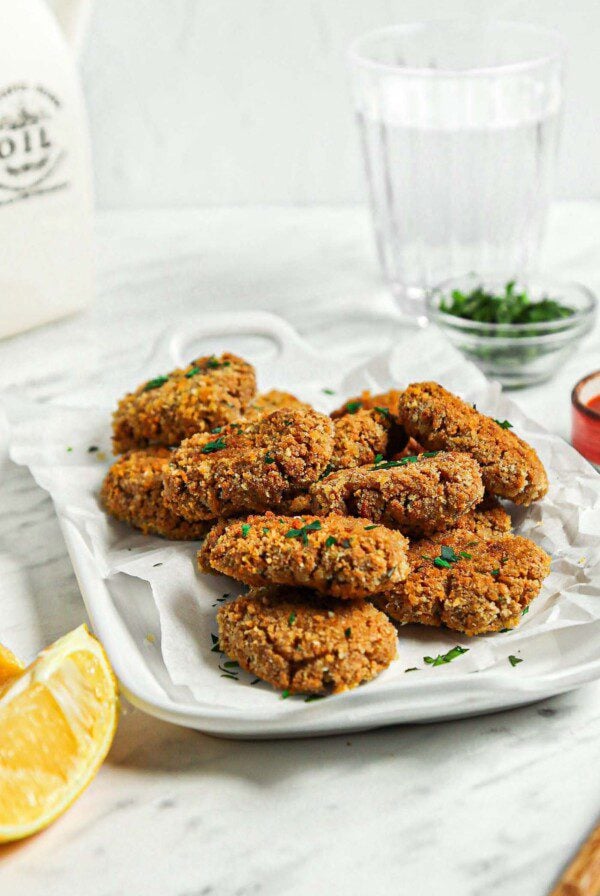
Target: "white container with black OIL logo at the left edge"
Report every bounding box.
[0,0,93,337]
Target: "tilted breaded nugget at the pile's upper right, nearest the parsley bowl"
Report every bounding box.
[399,383,548,505]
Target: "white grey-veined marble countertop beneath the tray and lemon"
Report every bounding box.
[0,205,600,896]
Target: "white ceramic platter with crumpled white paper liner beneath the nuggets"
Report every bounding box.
[7,313,600,738]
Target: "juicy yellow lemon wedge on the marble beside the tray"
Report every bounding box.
[0,625,118,843]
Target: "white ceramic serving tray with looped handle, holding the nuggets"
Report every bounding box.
[8,313,600,738]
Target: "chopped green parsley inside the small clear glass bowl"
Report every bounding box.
[439,280,575,324]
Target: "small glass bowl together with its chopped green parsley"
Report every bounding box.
[427,274,597,388]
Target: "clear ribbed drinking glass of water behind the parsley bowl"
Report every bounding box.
[350,21,564,313]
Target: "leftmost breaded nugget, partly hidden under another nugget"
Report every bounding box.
[100,445,210,541]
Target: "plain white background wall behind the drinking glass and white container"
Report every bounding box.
[82,0,600,208]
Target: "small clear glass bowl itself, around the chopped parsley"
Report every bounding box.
[426,274,597,389]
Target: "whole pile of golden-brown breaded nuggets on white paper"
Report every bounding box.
[102,353,550,695]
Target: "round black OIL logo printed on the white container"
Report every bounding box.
[0,84,68,205]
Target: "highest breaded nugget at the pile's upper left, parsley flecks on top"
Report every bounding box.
[113,353,256,454]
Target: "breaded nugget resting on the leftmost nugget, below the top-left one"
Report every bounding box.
[163,408,333,522]
